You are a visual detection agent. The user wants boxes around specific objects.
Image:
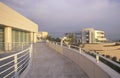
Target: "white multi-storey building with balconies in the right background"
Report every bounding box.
[82,28,107,43]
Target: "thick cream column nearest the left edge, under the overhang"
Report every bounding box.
[4,27,12,51]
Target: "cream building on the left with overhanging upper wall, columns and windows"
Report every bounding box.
[0,2,38,50]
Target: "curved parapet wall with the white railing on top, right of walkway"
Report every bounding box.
[47,43,120,78]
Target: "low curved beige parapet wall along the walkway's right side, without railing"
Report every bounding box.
[47,43,120,78]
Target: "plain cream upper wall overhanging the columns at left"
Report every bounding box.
[0,2,38,32]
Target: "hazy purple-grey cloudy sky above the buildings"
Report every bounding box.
[0,0,120,39]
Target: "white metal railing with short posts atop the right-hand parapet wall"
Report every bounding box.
[49,42,120,73]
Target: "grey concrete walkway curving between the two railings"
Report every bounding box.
[25,43,88,78]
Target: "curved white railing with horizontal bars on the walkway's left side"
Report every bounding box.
[0,44,32,78]
